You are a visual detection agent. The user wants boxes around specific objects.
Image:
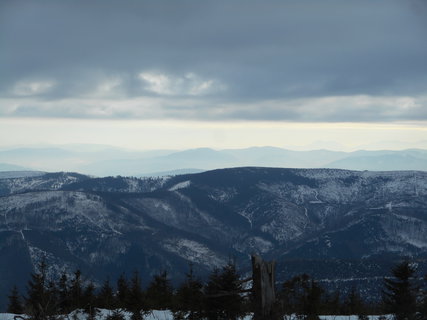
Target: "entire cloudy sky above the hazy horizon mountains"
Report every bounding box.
[0,0,427,150]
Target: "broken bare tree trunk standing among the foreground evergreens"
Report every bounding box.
[252,255,279,320]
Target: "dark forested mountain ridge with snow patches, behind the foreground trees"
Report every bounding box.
[0,167,427,308]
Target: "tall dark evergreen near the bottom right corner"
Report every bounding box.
[383,261,417,320]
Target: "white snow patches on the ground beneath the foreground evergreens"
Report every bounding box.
[0,309,391,320]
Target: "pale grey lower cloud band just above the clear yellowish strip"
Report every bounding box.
[0,96,427,122]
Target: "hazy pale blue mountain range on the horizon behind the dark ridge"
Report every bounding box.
[0,145,427,176]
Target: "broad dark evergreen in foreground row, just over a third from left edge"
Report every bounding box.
[147,271,173,310]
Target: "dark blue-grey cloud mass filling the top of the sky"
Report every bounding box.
[0,0,427,121]
